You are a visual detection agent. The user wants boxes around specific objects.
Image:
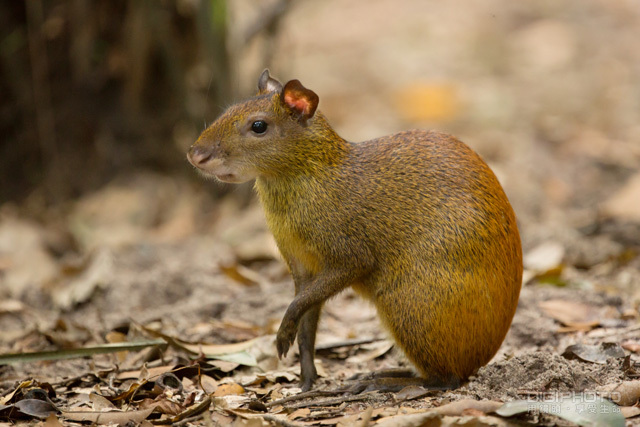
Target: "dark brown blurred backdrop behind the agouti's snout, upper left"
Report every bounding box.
[0,0,288,204]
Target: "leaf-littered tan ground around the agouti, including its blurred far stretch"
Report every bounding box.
[0,0,640,426]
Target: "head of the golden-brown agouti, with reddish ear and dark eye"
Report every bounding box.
[187,70,323,183]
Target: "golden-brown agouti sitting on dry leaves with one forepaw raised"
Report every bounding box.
[188,70,522,390]
